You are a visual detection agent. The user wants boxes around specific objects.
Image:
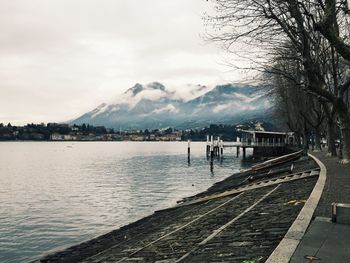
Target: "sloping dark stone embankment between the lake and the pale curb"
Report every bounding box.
[41,154,320,263]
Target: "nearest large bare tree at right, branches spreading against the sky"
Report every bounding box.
[209,0,350,163]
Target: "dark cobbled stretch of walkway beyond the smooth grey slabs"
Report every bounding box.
[312,151,350,217]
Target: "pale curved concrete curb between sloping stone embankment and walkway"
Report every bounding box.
[266,154,327,263]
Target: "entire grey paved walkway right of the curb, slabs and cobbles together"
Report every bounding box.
[290,152,350,263]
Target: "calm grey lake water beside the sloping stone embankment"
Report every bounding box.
[0,142,252,262]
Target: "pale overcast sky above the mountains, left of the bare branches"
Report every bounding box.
[0,0,252,124]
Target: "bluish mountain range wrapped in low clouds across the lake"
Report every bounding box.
[70,82,271,129]
